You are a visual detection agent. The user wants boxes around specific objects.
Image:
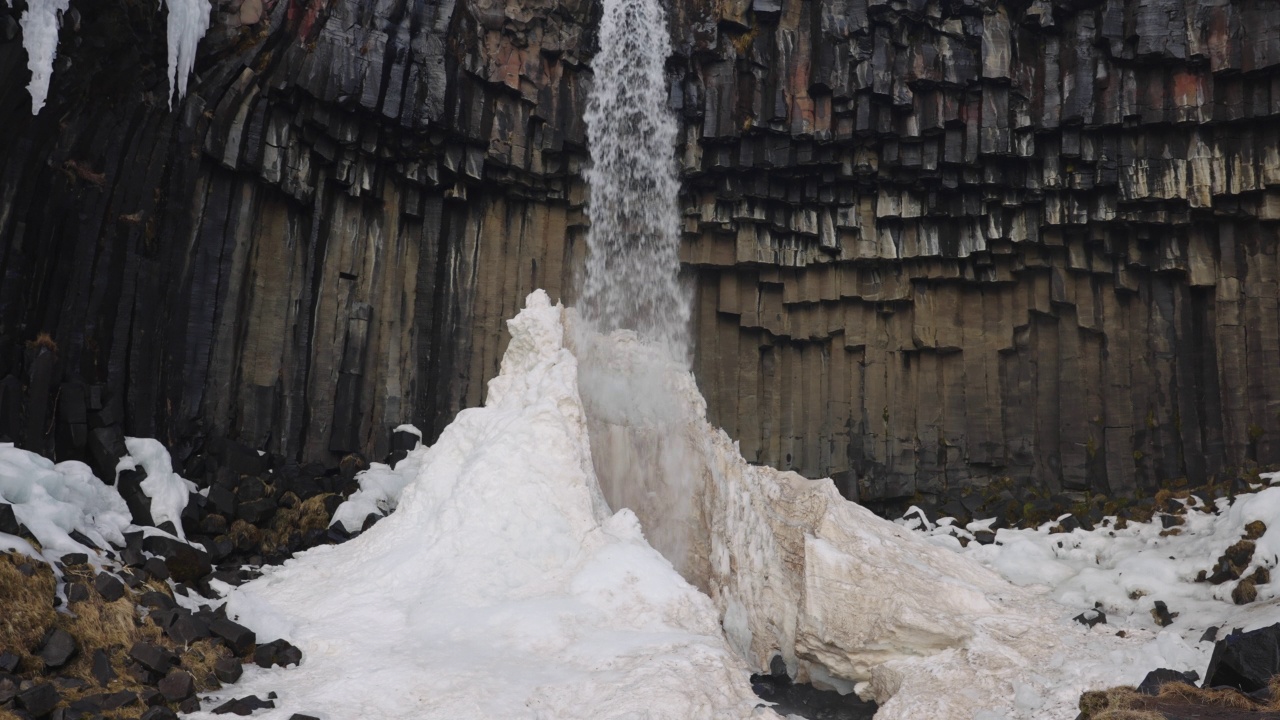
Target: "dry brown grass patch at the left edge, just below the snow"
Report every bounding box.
[0,553,58,670]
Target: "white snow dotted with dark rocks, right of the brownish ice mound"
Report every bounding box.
[904,473,1280,682]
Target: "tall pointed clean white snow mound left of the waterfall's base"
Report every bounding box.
[193,291,776,720]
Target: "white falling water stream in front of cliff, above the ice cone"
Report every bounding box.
[579,0,689,359]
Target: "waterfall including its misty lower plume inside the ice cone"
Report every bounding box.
[571,0,707,576]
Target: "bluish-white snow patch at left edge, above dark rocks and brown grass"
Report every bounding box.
[0,443,129,564]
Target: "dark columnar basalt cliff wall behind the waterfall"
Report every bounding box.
[0,0,1280,500]
